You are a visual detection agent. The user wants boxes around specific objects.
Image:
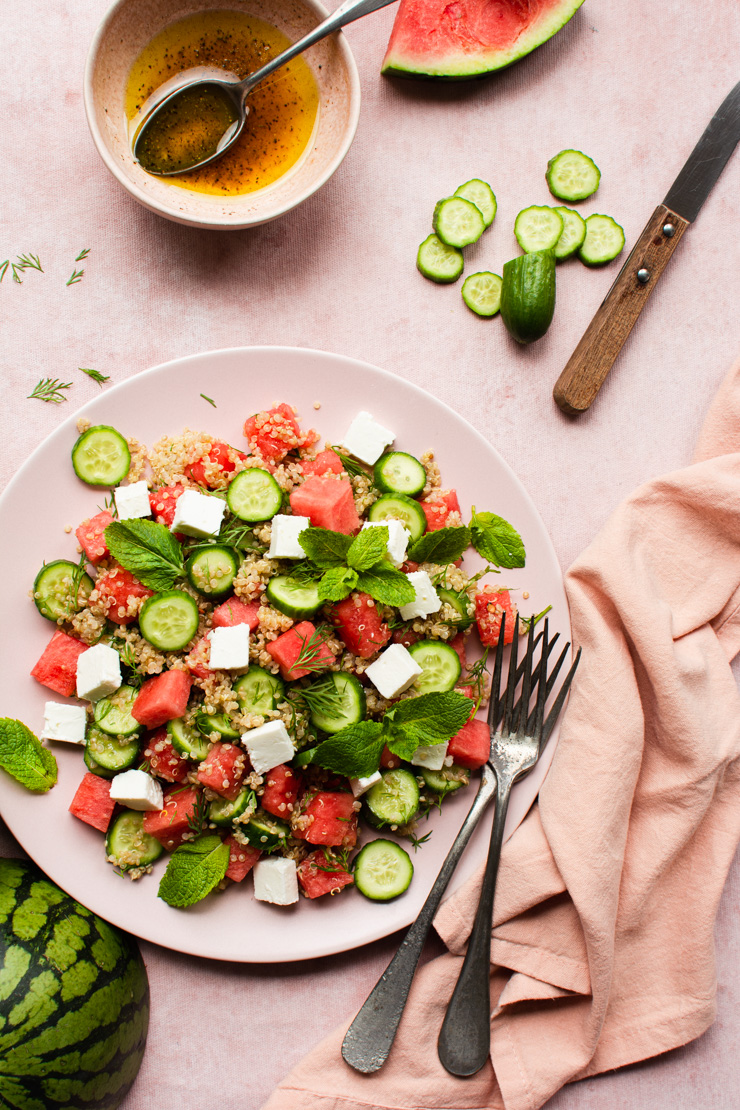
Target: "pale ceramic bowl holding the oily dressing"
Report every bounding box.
[84,0,359,230]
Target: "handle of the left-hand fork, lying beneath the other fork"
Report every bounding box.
[342,765,496,1074]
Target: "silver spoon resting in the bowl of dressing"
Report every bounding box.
[129,0,394,178]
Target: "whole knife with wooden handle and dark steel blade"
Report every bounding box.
[553,81,740,415]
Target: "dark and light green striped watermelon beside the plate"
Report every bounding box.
[0,859,149,1110]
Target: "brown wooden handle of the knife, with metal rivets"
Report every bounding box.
[553,204,689,415]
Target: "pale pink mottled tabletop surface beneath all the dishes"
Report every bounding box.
[0,0,740,1110]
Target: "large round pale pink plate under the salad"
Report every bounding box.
[0,347,570,962]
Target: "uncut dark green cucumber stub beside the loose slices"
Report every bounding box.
[501,251,555,343]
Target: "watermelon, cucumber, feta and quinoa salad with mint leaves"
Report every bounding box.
[21,403,541,907]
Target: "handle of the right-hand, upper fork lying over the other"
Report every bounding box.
[437,774,514,1078]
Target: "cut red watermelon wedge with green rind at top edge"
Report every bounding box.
[381,0,584,81]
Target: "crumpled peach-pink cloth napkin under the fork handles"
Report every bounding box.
[264,363,740,1110]
